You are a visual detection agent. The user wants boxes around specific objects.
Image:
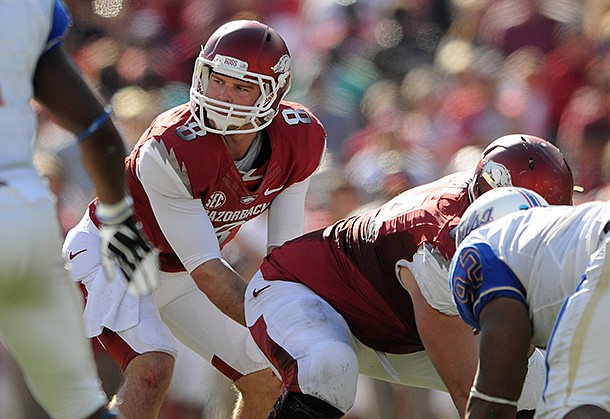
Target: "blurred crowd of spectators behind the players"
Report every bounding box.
[0,0,610,419]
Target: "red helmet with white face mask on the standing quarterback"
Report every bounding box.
[190,20,291,135]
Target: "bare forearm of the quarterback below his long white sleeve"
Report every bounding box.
[191,259,246,326]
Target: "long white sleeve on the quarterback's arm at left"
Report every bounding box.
[138,140,220,273]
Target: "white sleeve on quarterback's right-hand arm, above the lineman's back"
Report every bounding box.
[267,177,311,249]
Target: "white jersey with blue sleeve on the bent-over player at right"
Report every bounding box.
[449,202,610,347]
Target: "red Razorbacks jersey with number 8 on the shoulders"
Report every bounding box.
[90,102,326,272]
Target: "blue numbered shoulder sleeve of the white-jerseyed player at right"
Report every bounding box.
[449,242,526,330]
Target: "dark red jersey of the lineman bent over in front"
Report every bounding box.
[261,173,471,354]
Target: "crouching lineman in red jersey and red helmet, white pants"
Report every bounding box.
[245,135,573,419]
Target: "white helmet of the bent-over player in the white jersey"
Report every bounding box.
[455,186,549,246]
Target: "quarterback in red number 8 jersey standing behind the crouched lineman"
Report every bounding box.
[64,21,326,419]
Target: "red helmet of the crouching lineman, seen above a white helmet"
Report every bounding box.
[471,134,574,205]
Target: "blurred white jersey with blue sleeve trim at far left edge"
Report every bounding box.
[0,0,70,199]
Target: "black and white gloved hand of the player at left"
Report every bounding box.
[96,199,159,295]
